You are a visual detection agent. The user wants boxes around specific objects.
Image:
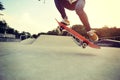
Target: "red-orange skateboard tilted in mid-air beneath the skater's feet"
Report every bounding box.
[56,19,100,49]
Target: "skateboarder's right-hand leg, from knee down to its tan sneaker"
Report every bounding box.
[75,0,98,41]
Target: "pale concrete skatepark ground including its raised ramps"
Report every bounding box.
[0,35,120,80]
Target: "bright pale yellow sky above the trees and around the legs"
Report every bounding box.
[0,0,120,34]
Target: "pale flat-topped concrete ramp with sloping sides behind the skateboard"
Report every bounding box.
[33,35,78,47]
